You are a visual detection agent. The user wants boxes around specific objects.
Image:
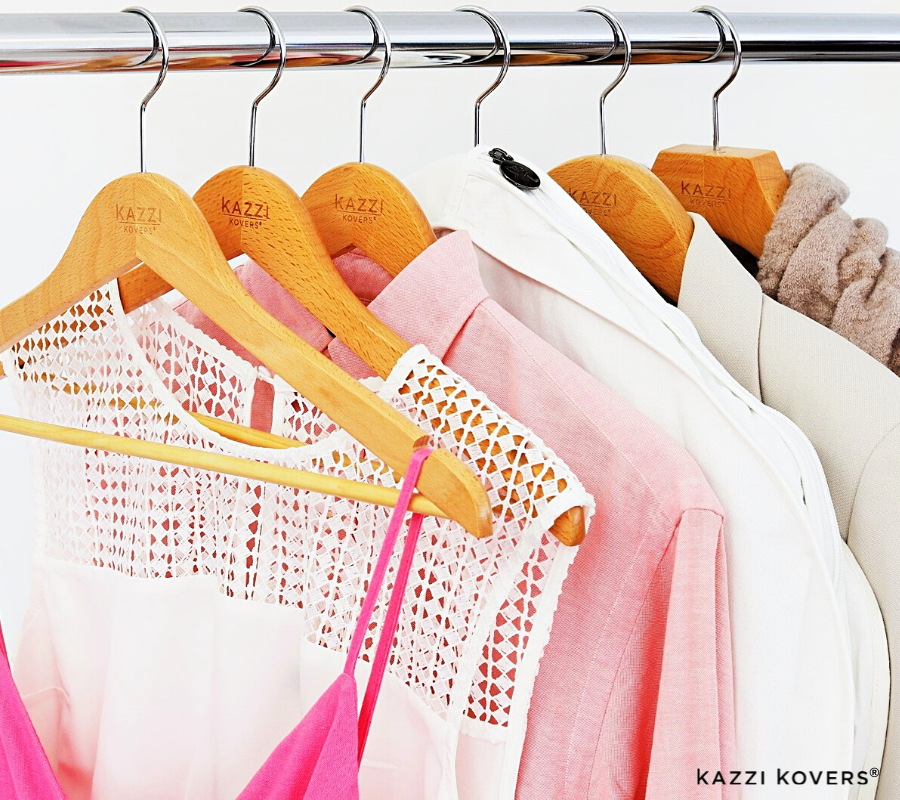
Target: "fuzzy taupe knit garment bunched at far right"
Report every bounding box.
[757,164,900,375]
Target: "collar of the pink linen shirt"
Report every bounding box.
[328,231,488,375]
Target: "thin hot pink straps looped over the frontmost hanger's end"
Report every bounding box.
[344,448,432,761]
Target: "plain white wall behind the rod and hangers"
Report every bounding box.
[0,0,900,641]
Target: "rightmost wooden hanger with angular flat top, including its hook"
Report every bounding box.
[653,6,789,258]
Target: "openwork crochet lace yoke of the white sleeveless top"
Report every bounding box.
[3,284,593,726]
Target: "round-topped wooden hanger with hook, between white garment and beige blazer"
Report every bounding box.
[550,6,694,300]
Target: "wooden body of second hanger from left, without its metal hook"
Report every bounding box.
[194,166,409,378]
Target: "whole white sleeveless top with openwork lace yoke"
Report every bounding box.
[2,282,592,800]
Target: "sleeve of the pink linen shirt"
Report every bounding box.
[589,509,738,800]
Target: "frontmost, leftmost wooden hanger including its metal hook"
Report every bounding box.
[0,9,493,537]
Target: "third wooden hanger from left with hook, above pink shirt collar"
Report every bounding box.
[303,6,436,276]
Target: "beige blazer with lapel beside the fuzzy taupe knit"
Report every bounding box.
[678,214,900,800]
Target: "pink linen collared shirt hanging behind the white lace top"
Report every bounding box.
[172,232,738,800]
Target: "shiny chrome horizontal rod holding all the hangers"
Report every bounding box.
[0,12,900,73]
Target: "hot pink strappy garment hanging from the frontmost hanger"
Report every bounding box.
[0,448,431,800]
